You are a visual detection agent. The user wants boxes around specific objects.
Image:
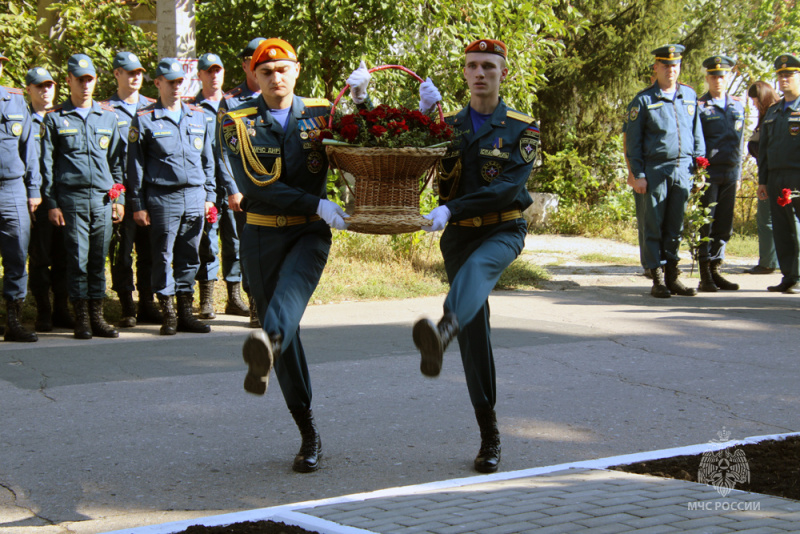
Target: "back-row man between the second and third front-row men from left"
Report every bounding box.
[103,52,164,328]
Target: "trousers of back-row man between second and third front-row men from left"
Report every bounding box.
[111,207,153,293]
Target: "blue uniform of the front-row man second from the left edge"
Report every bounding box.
[42,100,125,300]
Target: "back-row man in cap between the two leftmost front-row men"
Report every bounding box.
[25,67,75,332]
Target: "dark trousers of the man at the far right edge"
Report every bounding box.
[767,170,800,282]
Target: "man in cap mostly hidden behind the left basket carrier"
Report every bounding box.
[220,37,266,328]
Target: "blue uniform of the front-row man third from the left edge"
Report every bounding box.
[128,101,216,296]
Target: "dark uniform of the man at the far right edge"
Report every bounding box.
[758,97,800,283]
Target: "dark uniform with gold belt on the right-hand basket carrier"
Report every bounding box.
[439,100,539,409]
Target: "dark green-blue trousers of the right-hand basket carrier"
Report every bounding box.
[439,219,526,409]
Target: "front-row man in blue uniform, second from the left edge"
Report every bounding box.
[42,54,125,339]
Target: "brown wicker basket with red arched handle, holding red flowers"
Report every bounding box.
[325,65,447,234]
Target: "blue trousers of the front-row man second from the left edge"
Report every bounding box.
[57,188,112,300]
